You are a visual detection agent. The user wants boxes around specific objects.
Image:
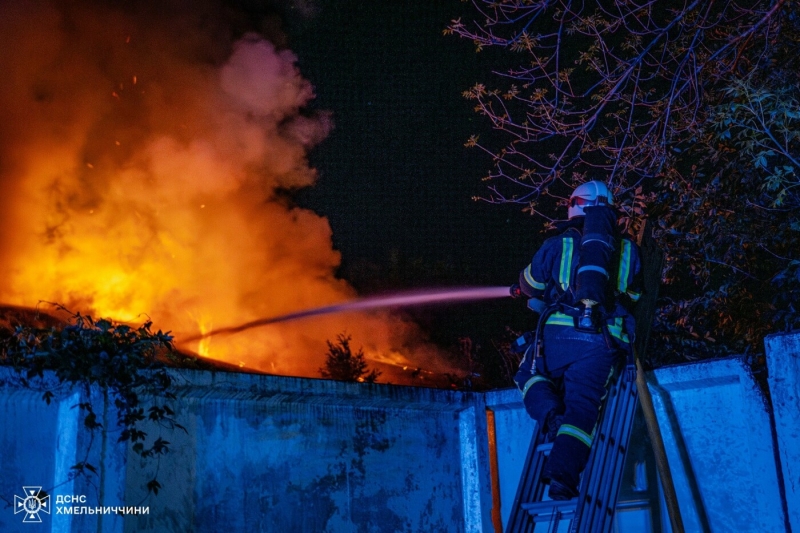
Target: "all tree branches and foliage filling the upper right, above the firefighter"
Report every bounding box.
[446,0,800,364]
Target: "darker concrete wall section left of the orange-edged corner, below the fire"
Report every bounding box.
[0,369,491,533]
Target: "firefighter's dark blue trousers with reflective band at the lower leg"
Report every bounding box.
[515,325,620,489]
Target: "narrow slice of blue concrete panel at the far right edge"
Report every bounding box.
[764,332,800,531]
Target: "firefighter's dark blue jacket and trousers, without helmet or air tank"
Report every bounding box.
[514,219,641,490]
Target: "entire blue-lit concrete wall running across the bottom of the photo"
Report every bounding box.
[0,335,800,533]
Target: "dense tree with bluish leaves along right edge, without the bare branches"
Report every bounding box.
[651,4,800,357]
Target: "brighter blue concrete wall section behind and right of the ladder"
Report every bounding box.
[486,354,800,533]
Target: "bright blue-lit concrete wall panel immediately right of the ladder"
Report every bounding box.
[648,358,784,533]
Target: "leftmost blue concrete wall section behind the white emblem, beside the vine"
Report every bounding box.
[0,368,124,533]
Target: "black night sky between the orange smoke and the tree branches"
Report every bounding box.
[284,0,542,342]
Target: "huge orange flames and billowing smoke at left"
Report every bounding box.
[0,0,450,382]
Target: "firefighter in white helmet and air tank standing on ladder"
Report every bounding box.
[511,181,641,500]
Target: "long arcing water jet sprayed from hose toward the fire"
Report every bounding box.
[182,287,510,342]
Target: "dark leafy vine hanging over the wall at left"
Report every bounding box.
[0,308,188,494]
